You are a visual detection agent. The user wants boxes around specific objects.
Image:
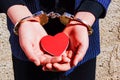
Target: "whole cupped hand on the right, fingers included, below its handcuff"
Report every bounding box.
[43,25,89,72]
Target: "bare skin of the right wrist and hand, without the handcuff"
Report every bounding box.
[43,12,95,72]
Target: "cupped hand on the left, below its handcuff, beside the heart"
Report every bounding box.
[19,21,61,66]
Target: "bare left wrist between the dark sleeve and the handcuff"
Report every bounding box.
[7,5,32,24]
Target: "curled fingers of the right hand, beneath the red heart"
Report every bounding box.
[42,50,73,72]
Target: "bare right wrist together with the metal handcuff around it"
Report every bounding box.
[60,12,95,35]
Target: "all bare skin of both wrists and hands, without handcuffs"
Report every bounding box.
[7,5,95,72]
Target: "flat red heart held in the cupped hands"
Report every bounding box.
[40,32,69,56]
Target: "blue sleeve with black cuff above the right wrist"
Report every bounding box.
[76,0,111,19]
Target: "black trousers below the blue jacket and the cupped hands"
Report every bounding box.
[13,57,96,80]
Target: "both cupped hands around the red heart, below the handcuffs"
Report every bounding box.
[19,22,89,71]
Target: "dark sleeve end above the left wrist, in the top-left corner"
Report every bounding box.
[0,0,25,13]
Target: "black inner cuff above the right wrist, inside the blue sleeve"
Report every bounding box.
[77,0,104,19]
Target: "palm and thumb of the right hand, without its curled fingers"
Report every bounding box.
[63,25,89,66]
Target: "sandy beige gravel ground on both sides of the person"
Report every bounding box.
[0,0,120,80]
